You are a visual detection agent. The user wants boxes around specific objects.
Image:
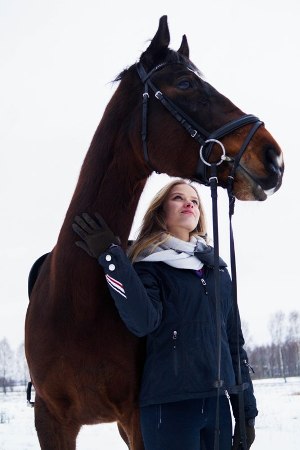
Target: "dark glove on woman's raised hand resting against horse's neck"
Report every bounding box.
[72,213,120,258]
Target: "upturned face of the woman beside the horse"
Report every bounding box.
[163,184,200,241]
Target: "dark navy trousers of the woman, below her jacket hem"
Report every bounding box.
[140,396,232,450]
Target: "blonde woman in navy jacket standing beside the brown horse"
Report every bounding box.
[73,179,257,450]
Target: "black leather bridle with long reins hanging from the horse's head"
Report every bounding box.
[136,63,263,450]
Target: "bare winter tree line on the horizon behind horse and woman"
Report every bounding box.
[0,311,300,393]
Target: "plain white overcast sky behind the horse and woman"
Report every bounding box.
[0,0,300,347]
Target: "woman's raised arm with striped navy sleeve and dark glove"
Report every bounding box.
[72,213,162,336]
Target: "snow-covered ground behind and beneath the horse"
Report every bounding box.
[0,377,300,450]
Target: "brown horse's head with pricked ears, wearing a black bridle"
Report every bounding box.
[131,16,284,200]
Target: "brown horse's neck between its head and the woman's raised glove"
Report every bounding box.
[54,77,150,253]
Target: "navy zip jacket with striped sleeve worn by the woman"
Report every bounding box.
[98,246,257,419]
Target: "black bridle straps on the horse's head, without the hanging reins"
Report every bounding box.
[136,62,263,186]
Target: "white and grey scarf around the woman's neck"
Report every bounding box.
[136,236,208,270]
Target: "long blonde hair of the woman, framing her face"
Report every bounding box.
[128,178,207,262]
